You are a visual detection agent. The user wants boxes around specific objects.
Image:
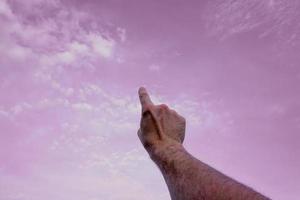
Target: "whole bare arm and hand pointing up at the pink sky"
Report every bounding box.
[138,87,269,200]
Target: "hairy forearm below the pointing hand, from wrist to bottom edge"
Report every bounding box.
[149,143,268,200]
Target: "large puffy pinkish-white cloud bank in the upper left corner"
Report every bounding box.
[0,0,125,67]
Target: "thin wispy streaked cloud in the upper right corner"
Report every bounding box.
[203,0,300,47]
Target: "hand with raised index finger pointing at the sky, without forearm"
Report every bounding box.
[138,87,185,151]
